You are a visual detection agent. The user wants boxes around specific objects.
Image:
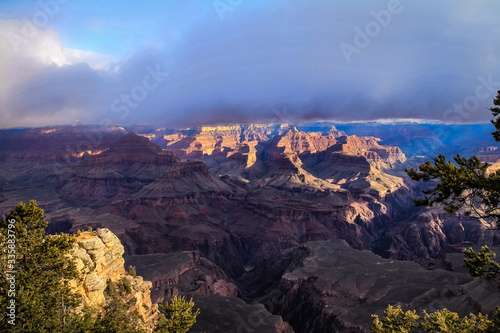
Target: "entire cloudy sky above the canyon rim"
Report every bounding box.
[0,0,500,128]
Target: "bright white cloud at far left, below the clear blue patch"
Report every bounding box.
[0,20,116,127]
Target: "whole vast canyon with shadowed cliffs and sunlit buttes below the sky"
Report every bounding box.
[0,124,500,333]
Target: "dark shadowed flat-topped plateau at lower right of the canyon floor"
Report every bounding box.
[262,240,498,333]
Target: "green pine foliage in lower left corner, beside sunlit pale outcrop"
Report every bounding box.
[0,201,150,333]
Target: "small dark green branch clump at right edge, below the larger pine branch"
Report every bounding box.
[464,245,500,280]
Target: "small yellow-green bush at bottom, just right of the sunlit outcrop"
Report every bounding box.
[155,296,200,333]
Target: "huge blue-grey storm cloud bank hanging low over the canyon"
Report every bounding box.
[0,0,500,127]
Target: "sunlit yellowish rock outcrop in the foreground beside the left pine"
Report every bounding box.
[71,229,159,332]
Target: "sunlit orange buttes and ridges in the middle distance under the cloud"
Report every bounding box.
[149,124,406,198]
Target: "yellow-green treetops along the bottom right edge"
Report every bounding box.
[370,305,494,333]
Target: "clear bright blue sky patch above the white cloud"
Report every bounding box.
[0,0,217,58]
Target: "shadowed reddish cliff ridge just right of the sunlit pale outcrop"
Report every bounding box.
[126,251,293,333]
